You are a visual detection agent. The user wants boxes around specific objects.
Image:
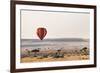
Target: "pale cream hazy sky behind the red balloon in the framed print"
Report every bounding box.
[21,10,90,39]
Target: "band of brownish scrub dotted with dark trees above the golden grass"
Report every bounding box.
[21,47,89,59]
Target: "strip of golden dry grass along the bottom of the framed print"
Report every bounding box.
[21,55,89,63]
